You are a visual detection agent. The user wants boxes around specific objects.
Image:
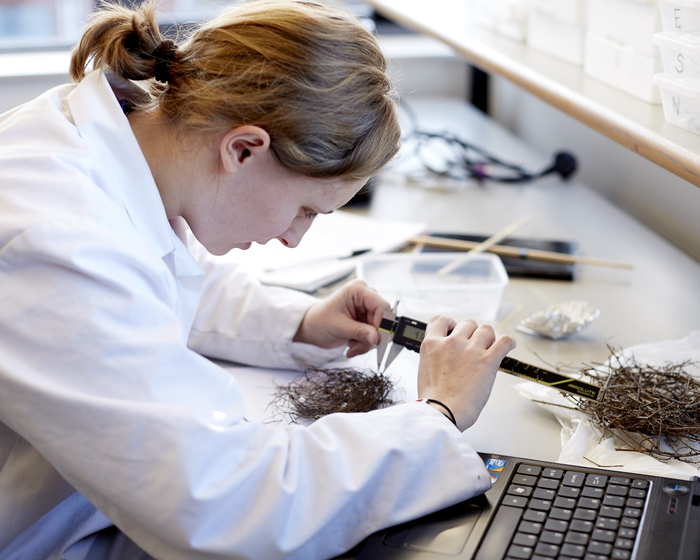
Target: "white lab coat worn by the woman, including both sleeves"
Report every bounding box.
[0,71,490,560]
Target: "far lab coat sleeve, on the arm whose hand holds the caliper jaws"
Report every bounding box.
[187,233,344,369]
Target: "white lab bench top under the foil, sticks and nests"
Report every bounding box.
[221,99,700,460]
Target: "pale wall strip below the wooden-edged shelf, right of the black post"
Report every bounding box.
[491,78,700,261]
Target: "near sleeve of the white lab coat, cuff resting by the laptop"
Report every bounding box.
[0,223,490,560]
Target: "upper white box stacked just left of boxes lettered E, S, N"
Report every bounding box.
[587,0,661,56]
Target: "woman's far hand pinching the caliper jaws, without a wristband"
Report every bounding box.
[294,280,391,358]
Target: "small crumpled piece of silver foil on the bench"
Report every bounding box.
[518,300,600,340]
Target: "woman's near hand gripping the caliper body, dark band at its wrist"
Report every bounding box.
[418,316,515,431]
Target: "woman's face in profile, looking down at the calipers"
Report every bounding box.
[184,144,366,255]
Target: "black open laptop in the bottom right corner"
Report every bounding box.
[356,454,700,560]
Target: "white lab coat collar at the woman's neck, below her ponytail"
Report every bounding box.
[67,70,202,276]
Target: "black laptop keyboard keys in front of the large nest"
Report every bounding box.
[492,463,649,560]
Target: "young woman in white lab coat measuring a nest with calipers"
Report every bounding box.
[0,0,514,560]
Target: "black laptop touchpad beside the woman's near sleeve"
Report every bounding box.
[383,502,482,556]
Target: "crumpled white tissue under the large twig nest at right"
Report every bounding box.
[515,331,700,479]
